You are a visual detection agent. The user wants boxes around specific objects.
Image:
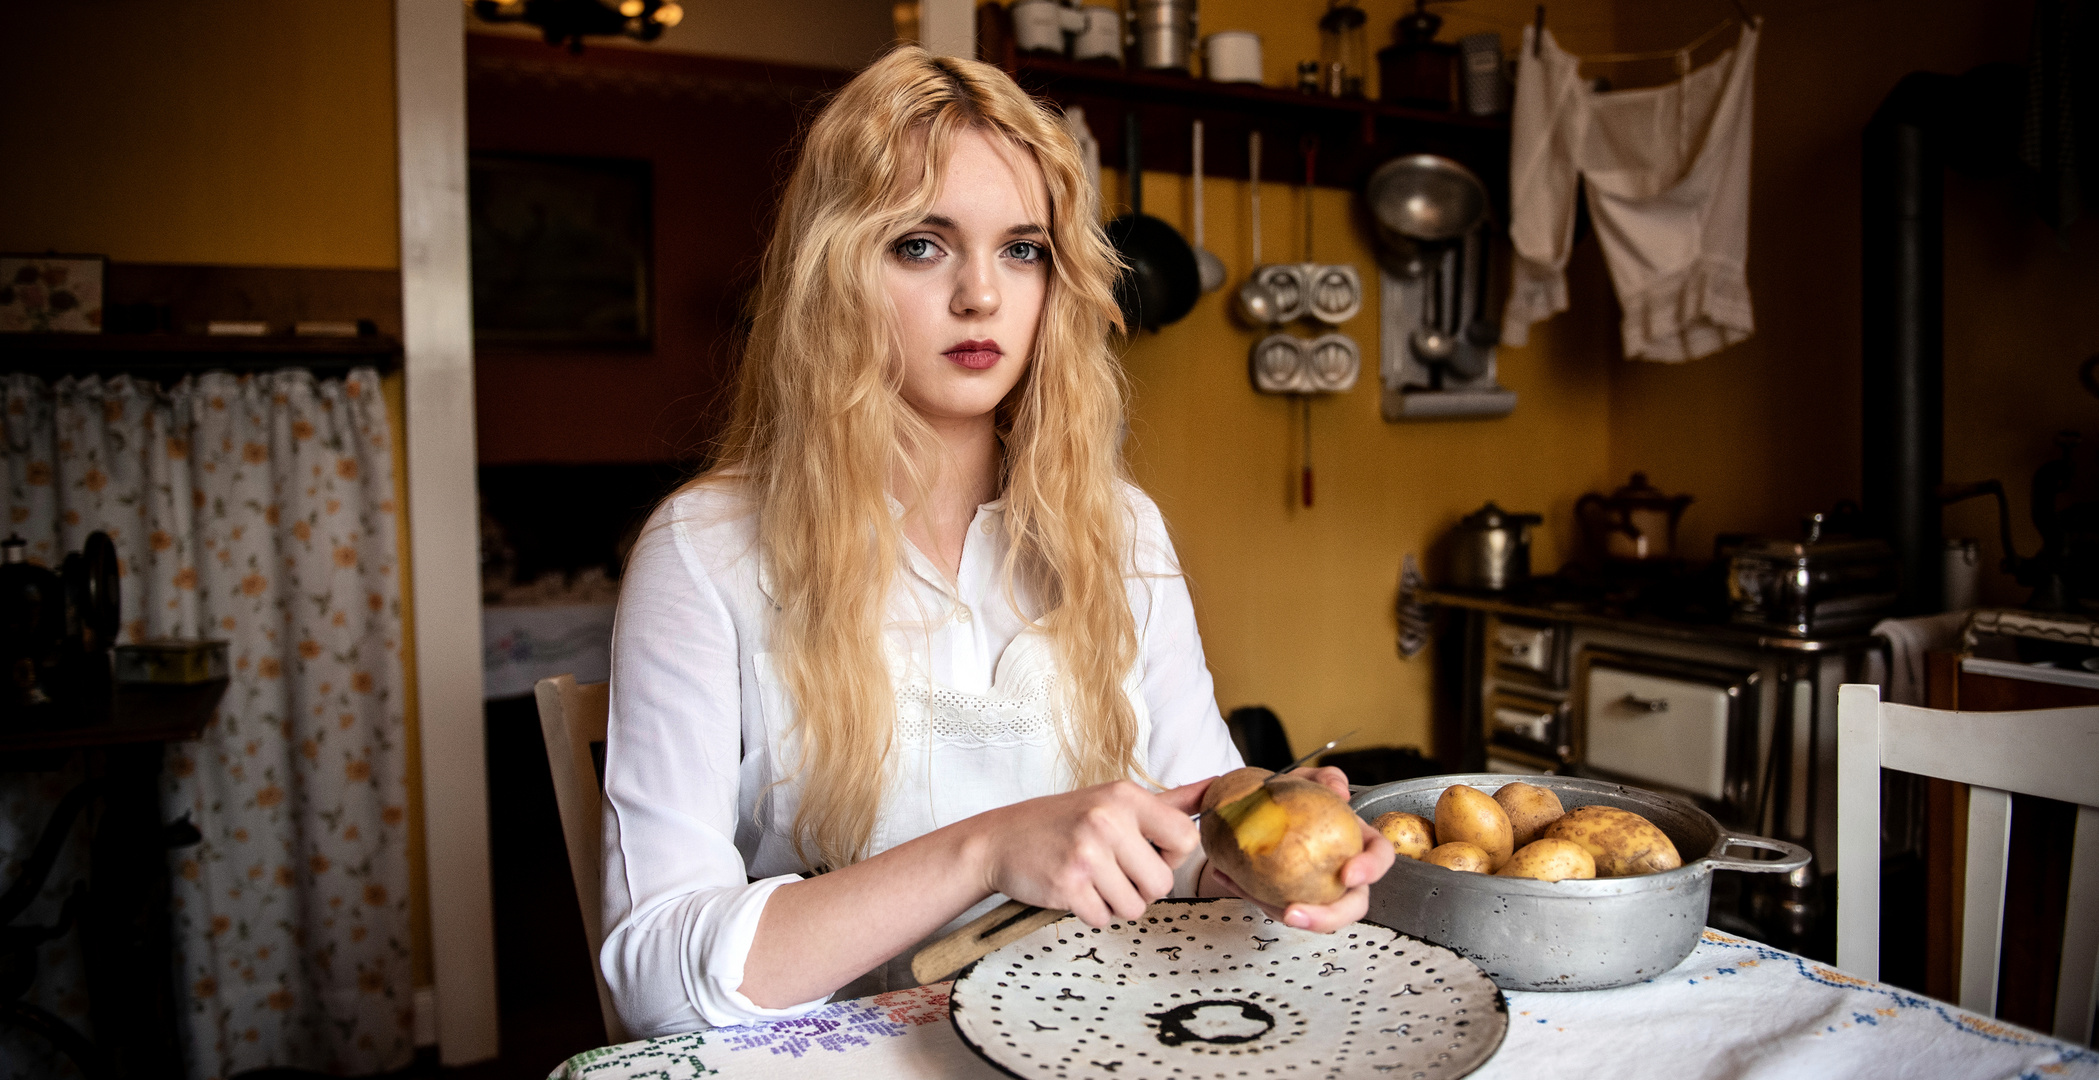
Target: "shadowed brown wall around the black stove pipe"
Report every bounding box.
[1595,0,2099,602]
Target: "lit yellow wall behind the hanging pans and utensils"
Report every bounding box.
[1104,0,1614,749]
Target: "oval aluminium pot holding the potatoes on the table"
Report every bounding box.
[1350,772,1811,990]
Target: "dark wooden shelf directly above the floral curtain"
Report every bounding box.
[0,333,401,384]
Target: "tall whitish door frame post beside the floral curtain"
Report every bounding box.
[395,0,497,1065]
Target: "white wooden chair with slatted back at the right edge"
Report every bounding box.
[1837,684,2099,1044]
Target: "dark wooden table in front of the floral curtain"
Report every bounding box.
[0,679,227,1078]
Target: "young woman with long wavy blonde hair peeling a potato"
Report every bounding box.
[600,48,1392,1036]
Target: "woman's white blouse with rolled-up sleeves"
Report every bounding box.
[598,484,1241,1038]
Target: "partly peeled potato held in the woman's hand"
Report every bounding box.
[1203,768,1362,908]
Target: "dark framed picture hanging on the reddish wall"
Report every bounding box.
[468,151,655,348]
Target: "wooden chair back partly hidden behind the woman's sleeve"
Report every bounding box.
[533,675,628,1042]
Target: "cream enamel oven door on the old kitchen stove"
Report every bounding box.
[1576,650,1748,803]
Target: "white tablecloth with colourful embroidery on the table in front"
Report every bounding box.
[552,929,2099,1080]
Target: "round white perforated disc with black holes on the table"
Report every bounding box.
[949,900,1509,1080]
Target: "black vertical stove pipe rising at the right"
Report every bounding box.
[1860,71,1956,614]
